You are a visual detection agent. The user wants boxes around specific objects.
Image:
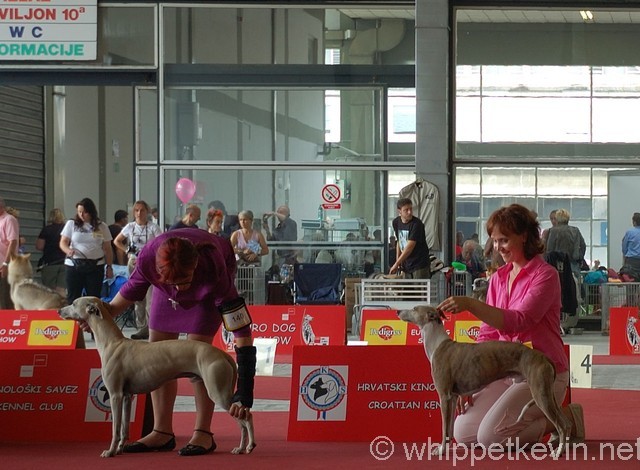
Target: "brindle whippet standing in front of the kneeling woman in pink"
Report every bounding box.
[398,305,571,457]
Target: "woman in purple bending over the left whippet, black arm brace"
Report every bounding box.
[111,228,256,456]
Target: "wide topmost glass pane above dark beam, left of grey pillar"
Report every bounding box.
[164,4,415,65]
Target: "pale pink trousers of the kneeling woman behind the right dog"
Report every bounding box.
[453,371,569,447]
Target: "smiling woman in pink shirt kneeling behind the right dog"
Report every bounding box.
[438,204,584,446]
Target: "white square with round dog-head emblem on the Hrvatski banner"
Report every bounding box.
[298,366,349,421]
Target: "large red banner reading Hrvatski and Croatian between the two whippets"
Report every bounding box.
[288,346,442,442]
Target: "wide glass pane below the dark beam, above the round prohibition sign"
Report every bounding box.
[164,87,383,164]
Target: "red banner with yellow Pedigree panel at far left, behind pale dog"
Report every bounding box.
[0,310,78,350]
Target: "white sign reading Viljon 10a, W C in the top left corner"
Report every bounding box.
[0,0,98,61]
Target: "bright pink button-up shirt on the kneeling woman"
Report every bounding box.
[478,256,569,373]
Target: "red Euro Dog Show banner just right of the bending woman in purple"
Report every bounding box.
[213,305,346,361]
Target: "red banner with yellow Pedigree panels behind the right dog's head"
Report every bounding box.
[360,309,482,346]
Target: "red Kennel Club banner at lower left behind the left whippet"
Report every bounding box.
[0,349,145,440]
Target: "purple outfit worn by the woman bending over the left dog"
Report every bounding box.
[119,228,238,335]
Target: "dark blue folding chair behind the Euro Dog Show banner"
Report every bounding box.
[293,263,342,305]
